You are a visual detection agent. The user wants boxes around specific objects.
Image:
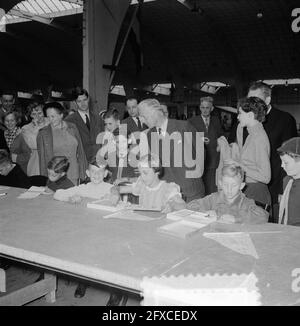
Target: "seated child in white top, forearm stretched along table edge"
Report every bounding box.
[53,159,112,203]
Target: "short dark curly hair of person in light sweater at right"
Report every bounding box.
[238,96,268,122]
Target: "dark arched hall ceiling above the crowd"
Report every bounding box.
[0,0,300,89]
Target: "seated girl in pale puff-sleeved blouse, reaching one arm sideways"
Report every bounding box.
[112,154,185,213]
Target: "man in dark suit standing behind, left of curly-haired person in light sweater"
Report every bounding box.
[189,96,223,195]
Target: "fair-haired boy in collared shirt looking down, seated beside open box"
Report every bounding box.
[186,163,269,224]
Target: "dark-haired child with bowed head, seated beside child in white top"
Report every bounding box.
[45,156,74,193]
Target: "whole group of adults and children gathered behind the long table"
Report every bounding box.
[0,82,300,305]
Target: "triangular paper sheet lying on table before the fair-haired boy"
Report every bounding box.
[203,232,259,259]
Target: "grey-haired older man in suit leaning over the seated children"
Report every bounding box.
[138,99,204,202]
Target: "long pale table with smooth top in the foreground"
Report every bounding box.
[0,188,300,305]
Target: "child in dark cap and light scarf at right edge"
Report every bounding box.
[278,137,300,226]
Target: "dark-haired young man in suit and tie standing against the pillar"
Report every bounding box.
[65,87,104,161]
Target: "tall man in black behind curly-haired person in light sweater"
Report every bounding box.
[248,82,298,222]
